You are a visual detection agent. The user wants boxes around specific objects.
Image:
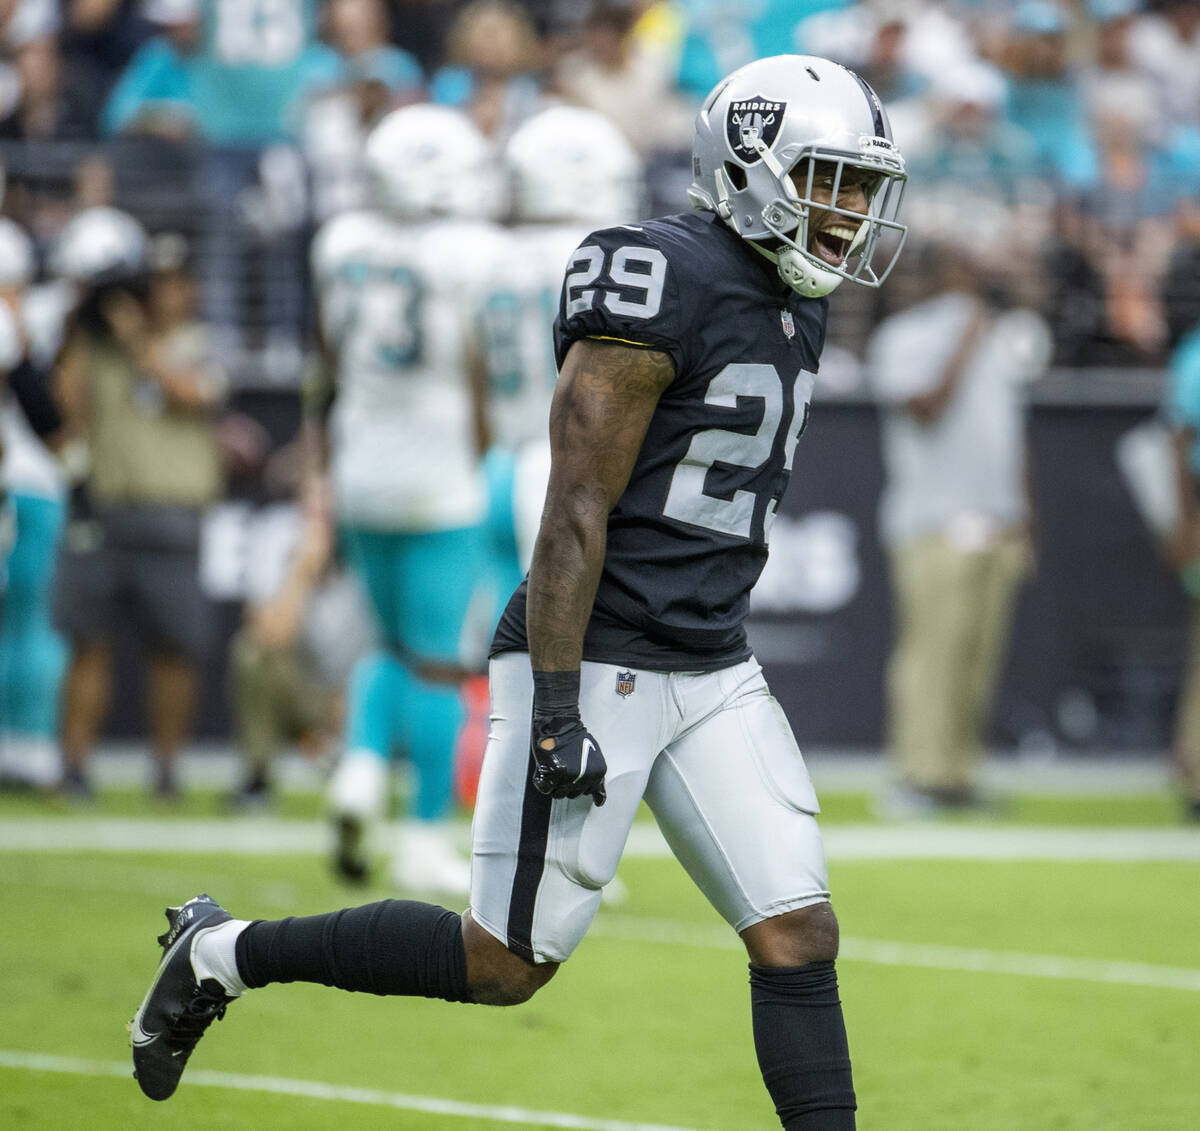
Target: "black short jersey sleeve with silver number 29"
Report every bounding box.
[554,225,691,372]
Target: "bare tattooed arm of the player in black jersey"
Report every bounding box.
[526,340,674,671]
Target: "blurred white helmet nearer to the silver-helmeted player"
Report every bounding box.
[504,106,642,225]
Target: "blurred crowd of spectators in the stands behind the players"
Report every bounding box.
[0,0,1200,364]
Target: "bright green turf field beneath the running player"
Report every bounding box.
[0,794,1200,1131]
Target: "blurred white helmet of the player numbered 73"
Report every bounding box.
[364,103,496,220]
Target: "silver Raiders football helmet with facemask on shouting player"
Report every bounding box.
[688,55,907,298]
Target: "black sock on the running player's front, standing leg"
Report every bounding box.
[750,962,856,1131]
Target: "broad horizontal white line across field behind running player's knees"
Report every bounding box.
[7,815,1200,862]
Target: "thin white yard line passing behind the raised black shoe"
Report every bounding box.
[0,1049,694,1131]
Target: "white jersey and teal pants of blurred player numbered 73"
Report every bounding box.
[312,211,500,819]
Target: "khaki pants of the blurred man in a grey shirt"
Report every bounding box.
[888,532,1030,790]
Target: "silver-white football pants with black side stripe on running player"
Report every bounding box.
[470,652,829,962]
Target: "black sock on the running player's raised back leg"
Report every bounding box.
[236,899,470,1001]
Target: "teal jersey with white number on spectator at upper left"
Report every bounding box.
[192,0,338,146]
